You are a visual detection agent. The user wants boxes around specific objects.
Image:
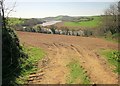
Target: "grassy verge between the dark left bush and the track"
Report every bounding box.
[16,47,45,84]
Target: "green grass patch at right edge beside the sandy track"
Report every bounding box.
[100,50,120,74]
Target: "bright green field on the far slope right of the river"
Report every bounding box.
[64,16,100,28]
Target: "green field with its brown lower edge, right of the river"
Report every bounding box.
[55,16,101,30]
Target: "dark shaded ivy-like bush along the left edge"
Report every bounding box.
[2,28,22,84]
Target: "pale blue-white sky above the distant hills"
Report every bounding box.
[5,0,117,18]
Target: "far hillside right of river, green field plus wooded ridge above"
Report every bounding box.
[51,16,102,30]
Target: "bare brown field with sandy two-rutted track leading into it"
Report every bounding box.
[17,32,117,84]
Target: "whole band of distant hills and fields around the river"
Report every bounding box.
[9,15,101,30]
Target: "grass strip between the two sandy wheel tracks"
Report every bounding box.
[67,61,90,84]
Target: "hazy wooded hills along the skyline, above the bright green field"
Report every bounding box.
[8,15,99,26]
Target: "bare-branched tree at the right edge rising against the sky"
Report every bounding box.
[103,3,119,34]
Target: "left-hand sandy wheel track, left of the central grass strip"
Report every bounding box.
[39,43,68,84]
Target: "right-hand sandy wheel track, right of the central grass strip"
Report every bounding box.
[72,45,118,84]
